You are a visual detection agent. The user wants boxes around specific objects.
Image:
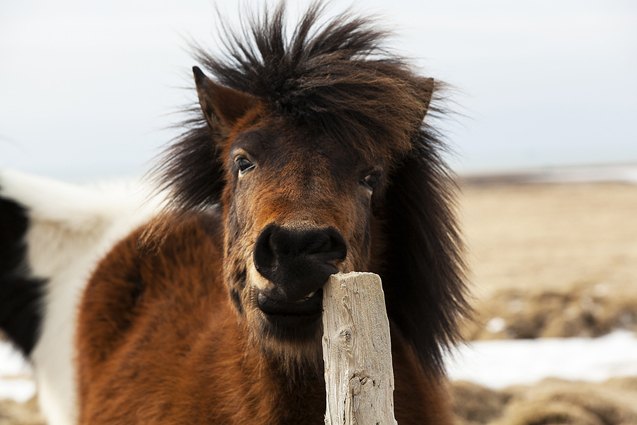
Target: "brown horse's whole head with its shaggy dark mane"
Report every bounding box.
[157,6,463,369]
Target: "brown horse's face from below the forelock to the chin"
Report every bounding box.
[223,124,382,352]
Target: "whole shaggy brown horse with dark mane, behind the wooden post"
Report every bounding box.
[0,4,467,425]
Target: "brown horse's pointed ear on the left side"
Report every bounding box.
[192,66,256,133]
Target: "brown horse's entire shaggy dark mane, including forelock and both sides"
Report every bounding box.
[158,2,468,373]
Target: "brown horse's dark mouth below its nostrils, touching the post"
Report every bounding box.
[257,289,323,322]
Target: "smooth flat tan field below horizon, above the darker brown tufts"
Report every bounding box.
[460,184,637,295]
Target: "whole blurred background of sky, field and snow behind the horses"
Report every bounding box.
[0,0,637,425]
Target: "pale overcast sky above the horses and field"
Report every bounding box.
[0,0,637,180]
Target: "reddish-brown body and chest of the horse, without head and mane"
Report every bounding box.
[78,213,451,425]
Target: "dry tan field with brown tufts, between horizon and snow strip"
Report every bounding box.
[460,184,637,339]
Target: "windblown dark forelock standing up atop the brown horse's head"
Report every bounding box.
[196,2,432,156]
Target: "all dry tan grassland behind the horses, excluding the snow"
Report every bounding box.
[0,182,637,425]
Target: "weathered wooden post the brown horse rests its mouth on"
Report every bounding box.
[323,273,396,425]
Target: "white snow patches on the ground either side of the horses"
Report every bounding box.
[0,331,637,401]
